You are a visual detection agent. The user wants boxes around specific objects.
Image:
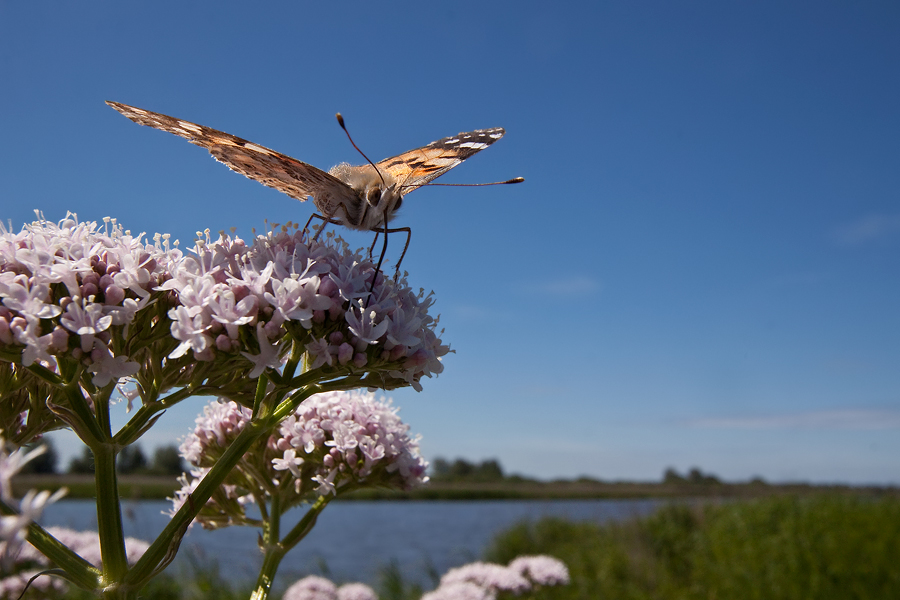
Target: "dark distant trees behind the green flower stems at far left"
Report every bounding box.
[21,438,185,475]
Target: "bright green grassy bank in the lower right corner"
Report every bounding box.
[487,495,900,600]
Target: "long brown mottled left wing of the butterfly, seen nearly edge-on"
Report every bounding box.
[107,101,358,216]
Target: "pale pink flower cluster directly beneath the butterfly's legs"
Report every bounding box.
[161,229,449,390]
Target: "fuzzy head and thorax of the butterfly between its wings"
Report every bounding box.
[328,163,403,230]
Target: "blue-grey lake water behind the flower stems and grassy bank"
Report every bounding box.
[41,500,664,589]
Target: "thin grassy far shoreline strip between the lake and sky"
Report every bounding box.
[13,475,900,500]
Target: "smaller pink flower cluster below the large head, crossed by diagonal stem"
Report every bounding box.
[173,391,428,528]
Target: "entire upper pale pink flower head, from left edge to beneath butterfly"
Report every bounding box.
[0,215,450,406]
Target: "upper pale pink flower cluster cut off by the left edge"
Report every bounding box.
[0,215,172,386]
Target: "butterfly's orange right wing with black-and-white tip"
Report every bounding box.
[378,127,506,194]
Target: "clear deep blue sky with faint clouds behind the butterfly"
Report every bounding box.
[0,0,900,484]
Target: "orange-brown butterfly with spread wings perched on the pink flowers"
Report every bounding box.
[106,101,522,236]
